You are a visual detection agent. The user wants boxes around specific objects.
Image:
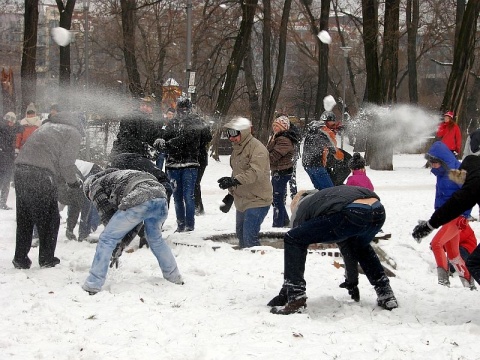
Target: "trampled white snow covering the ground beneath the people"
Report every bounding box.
[0,149,480,360]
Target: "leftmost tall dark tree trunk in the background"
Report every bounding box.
[20,0,38,114]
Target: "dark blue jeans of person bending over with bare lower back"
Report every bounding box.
[284,202,385,297]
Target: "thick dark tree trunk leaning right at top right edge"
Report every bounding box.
[440,0,480,123]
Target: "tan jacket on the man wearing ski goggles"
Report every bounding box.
[229,128,273,212]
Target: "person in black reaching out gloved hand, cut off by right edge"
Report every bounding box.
[412,155,480,283]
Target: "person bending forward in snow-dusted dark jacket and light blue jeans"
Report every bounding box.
[82,168,183,295]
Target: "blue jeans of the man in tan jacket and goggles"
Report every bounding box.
[236,206,270,249]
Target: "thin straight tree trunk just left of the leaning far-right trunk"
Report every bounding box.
[407,0,420,104]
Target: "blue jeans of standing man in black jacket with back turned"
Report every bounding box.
[167,168,198,231]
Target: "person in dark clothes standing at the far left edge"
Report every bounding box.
[0,112,23,210]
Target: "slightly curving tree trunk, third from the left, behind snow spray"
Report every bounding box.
[120,0,144,97]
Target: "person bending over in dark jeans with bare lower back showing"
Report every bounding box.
[268,185,398,315]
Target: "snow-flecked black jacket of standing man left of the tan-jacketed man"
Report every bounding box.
[163,112,206,169]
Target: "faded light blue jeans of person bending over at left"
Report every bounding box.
[85,198,181,291]
